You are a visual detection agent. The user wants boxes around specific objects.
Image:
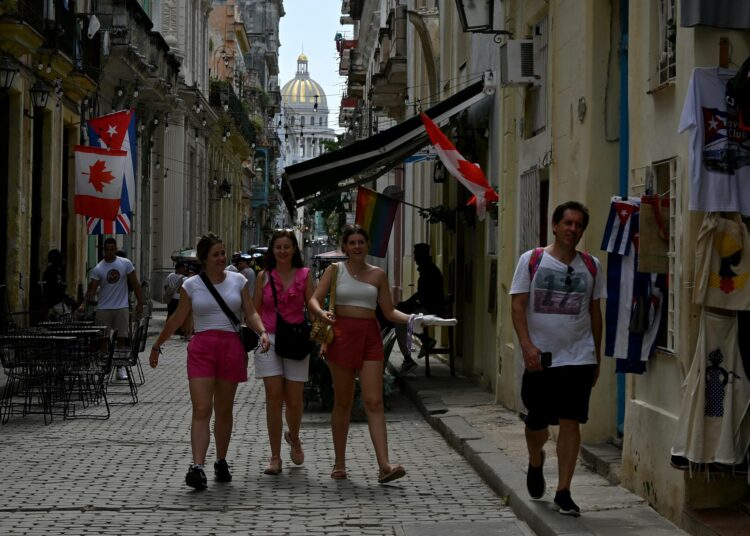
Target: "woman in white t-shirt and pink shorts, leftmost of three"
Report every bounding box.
[149,233,270,490]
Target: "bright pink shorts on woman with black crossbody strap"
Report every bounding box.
[187,329,247,383]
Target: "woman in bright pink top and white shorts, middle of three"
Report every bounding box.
[253,229,313,475]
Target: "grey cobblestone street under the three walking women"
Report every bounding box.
[0,313,531,536]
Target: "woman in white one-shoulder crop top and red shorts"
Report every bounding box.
[310,225,456,484]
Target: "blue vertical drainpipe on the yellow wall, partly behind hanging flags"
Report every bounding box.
[617,0,630,437]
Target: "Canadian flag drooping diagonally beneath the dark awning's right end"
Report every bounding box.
[419,112,500,220]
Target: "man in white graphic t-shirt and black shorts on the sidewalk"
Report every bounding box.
[510,201,606,516]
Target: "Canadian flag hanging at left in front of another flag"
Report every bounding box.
[75,145,128,220]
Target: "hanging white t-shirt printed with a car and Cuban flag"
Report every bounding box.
[677,67,750,215]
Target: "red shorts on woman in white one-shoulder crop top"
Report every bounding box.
[326,316,383,369]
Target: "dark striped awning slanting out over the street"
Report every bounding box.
[282,74,495,217]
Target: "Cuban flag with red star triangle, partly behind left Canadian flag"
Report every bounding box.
[86,109,138,234]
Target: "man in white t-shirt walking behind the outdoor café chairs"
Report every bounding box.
[79,238,143,379]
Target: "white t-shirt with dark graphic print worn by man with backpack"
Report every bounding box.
[510,251,607,367]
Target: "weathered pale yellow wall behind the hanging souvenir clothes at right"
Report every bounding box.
[621,2,750,524]
